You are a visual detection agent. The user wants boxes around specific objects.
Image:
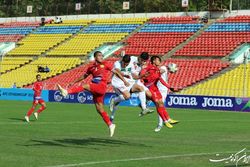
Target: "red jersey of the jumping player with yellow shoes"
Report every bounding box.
[141,64,170,88]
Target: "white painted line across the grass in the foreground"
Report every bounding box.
[43,151,246,167]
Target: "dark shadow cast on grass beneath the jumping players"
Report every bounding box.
[20,137,150,149]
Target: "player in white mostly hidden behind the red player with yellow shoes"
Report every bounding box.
[155,65,168,132]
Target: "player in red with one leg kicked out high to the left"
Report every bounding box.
[57,51,129,137]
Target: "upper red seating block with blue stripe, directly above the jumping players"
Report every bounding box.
[116,17,203,55]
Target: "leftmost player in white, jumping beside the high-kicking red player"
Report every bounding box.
[110,55,151,121]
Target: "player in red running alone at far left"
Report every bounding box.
[24,74,46,122]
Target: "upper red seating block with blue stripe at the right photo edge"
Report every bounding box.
[174,16,250,57]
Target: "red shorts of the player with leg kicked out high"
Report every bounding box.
[89,82,107,103]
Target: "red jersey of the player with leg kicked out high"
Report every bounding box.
[86,61,113,83]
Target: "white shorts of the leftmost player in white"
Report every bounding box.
[111,80,135,95]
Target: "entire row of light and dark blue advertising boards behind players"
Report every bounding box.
[0,88,250,112]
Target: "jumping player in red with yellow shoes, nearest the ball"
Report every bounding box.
[140,56,178,128]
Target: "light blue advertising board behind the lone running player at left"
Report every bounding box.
[0,88,49,101]
